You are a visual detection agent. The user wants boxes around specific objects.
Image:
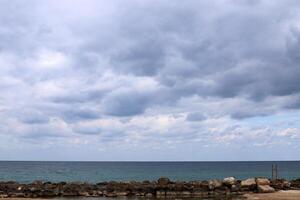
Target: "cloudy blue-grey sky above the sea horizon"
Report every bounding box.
[0,0,300,161]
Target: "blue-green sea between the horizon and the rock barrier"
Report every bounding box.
[0,161,300,183]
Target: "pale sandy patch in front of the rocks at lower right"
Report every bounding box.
[245,190,300,200]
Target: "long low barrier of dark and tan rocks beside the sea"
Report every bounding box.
[0,177,300,198]
